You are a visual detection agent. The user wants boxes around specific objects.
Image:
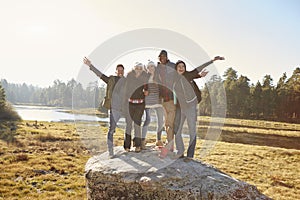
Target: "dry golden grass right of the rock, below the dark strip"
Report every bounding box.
[196,142,300,199]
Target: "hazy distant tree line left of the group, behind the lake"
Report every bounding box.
[1,79,105,108]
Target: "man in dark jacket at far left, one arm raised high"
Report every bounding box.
[83,57,126,158]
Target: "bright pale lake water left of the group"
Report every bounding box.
[14,105,108,122]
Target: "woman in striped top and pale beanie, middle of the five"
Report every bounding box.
[141,61,164,149]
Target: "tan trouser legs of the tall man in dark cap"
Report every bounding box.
[163,100,176,151]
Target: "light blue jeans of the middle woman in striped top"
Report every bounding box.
[142,107,164,140]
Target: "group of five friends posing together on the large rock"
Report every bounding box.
[83,50,224,158]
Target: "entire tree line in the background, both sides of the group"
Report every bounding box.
[0,67,300,122]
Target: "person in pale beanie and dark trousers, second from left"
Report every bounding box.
[124,63,148,153]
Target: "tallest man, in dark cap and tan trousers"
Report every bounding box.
[156,50,176,151]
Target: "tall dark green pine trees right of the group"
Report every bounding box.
[199,67,300,123]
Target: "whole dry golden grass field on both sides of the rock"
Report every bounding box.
[0,117,300,199]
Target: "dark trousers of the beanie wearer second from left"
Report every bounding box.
[124,103,145,149]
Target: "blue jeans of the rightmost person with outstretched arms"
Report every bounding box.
[174,102,197,158]
